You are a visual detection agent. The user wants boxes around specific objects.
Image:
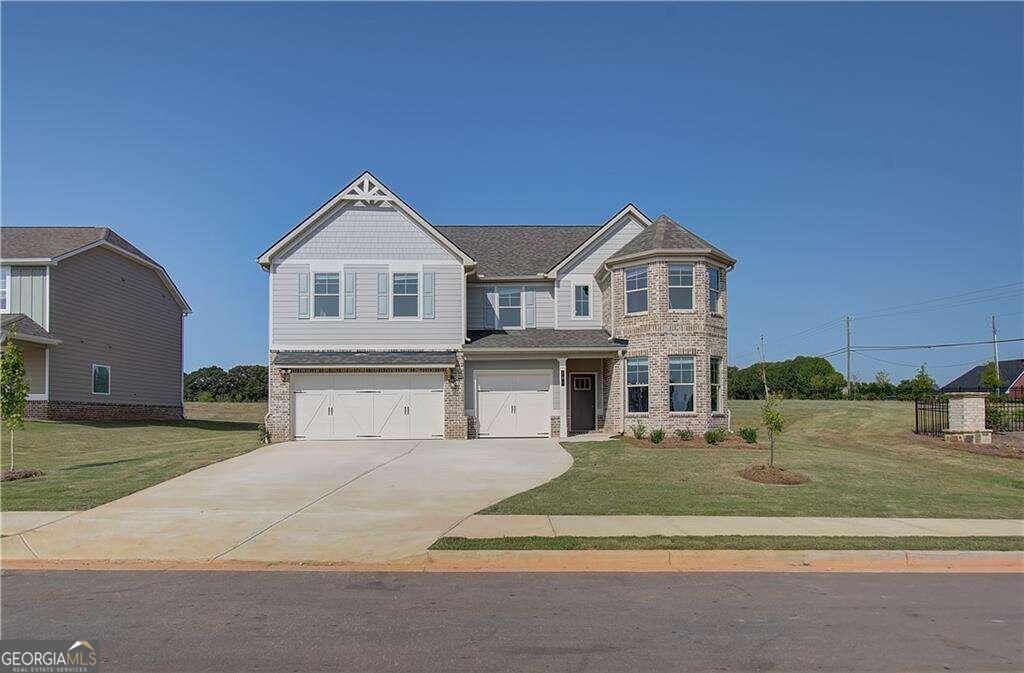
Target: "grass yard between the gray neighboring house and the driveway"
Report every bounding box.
[0,404,266,511]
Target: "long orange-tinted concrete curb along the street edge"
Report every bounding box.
[3,549,1024,573]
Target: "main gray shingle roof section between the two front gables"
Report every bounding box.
[434,224,601,278]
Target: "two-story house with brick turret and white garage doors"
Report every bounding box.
[258,173,735,440]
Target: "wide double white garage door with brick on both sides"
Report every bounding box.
[292,374,444,439]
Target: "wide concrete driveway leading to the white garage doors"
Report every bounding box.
[2,439,572,561]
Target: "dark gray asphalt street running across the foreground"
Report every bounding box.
[0,571,1024,673]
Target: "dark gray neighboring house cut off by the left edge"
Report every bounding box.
[0,231,191,420]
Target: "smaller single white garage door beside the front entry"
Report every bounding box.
[476,371,551,437]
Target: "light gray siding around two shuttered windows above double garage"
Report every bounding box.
[270,262,464,350]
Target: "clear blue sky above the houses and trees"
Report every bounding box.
[2,3,1024,382]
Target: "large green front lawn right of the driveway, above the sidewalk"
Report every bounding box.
[481,401,1024,518]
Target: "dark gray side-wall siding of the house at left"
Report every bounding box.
[49,248,182,407]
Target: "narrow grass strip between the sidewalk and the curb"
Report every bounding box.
[430,535,1024,551]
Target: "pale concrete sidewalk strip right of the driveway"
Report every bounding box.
[447,514,1024,538]
